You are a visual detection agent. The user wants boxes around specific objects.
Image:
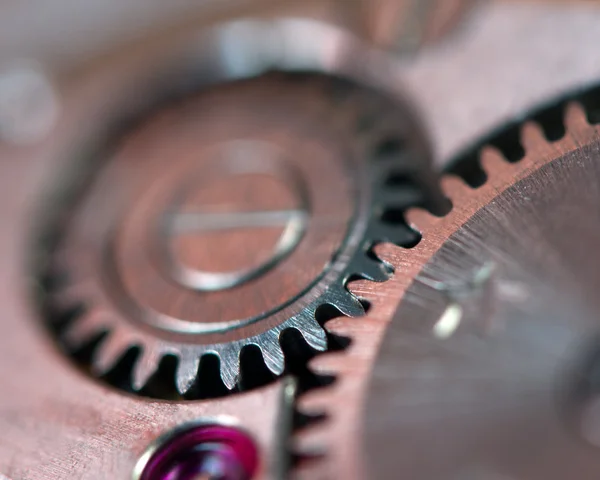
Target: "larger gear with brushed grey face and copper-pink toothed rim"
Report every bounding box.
[295,91,600,480]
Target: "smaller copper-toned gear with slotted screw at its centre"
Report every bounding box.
[40,73,436,398]
